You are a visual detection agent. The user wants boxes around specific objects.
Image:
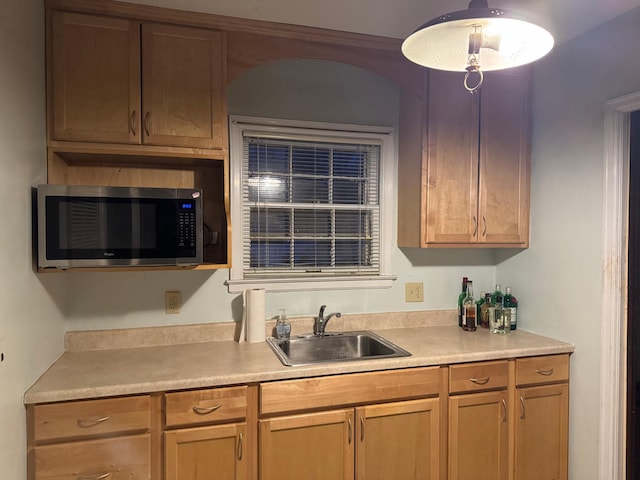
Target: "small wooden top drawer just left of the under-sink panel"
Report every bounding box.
[164,386,247,427]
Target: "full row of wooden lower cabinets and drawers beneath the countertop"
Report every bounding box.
[27,354,569,480]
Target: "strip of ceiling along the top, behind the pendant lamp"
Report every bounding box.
[126,0,640,43]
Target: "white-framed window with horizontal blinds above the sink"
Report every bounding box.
[228,117,394,292]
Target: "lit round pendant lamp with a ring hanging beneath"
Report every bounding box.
[402,0,554,93]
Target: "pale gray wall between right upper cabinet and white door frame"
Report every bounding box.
[497,9,640,480]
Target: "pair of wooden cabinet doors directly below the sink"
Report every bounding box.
[258,398,439,480]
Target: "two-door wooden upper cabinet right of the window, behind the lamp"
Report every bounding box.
[398,67,531,248]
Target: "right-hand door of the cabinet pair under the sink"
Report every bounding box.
[356,398,440,480]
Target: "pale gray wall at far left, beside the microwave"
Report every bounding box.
[0,0,66,480]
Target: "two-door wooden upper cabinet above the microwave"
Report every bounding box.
[49,11,226,149]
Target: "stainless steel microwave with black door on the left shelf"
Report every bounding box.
[36,185,203,269]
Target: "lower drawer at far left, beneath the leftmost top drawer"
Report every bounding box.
[33,434,151,480]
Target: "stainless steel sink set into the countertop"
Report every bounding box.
[267,331,411,366]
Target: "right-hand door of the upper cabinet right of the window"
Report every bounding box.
[478,67,531,246]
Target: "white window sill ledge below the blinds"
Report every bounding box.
[226,275,397,293]
